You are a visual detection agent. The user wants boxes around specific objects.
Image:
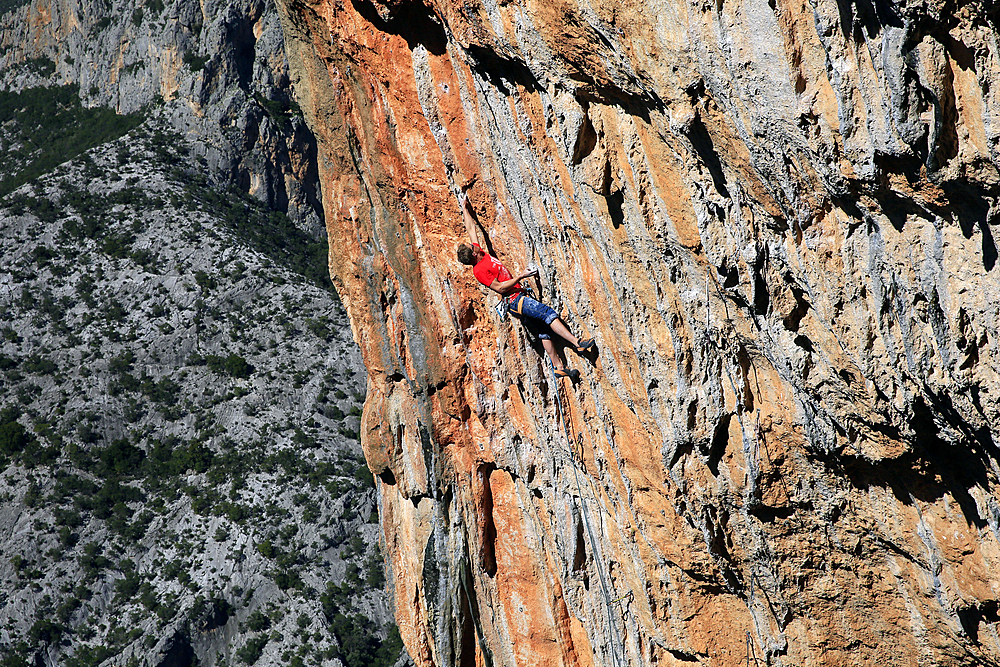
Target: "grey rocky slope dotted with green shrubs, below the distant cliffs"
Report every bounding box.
[0,120,400,667]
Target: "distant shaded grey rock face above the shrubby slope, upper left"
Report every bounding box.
[0,0,323,234]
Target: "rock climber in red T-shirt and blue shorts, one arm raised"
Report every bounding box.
[457,194,595,382]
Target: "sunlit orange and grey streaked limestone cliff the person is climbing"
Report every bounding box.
[278,0,1000,665]
